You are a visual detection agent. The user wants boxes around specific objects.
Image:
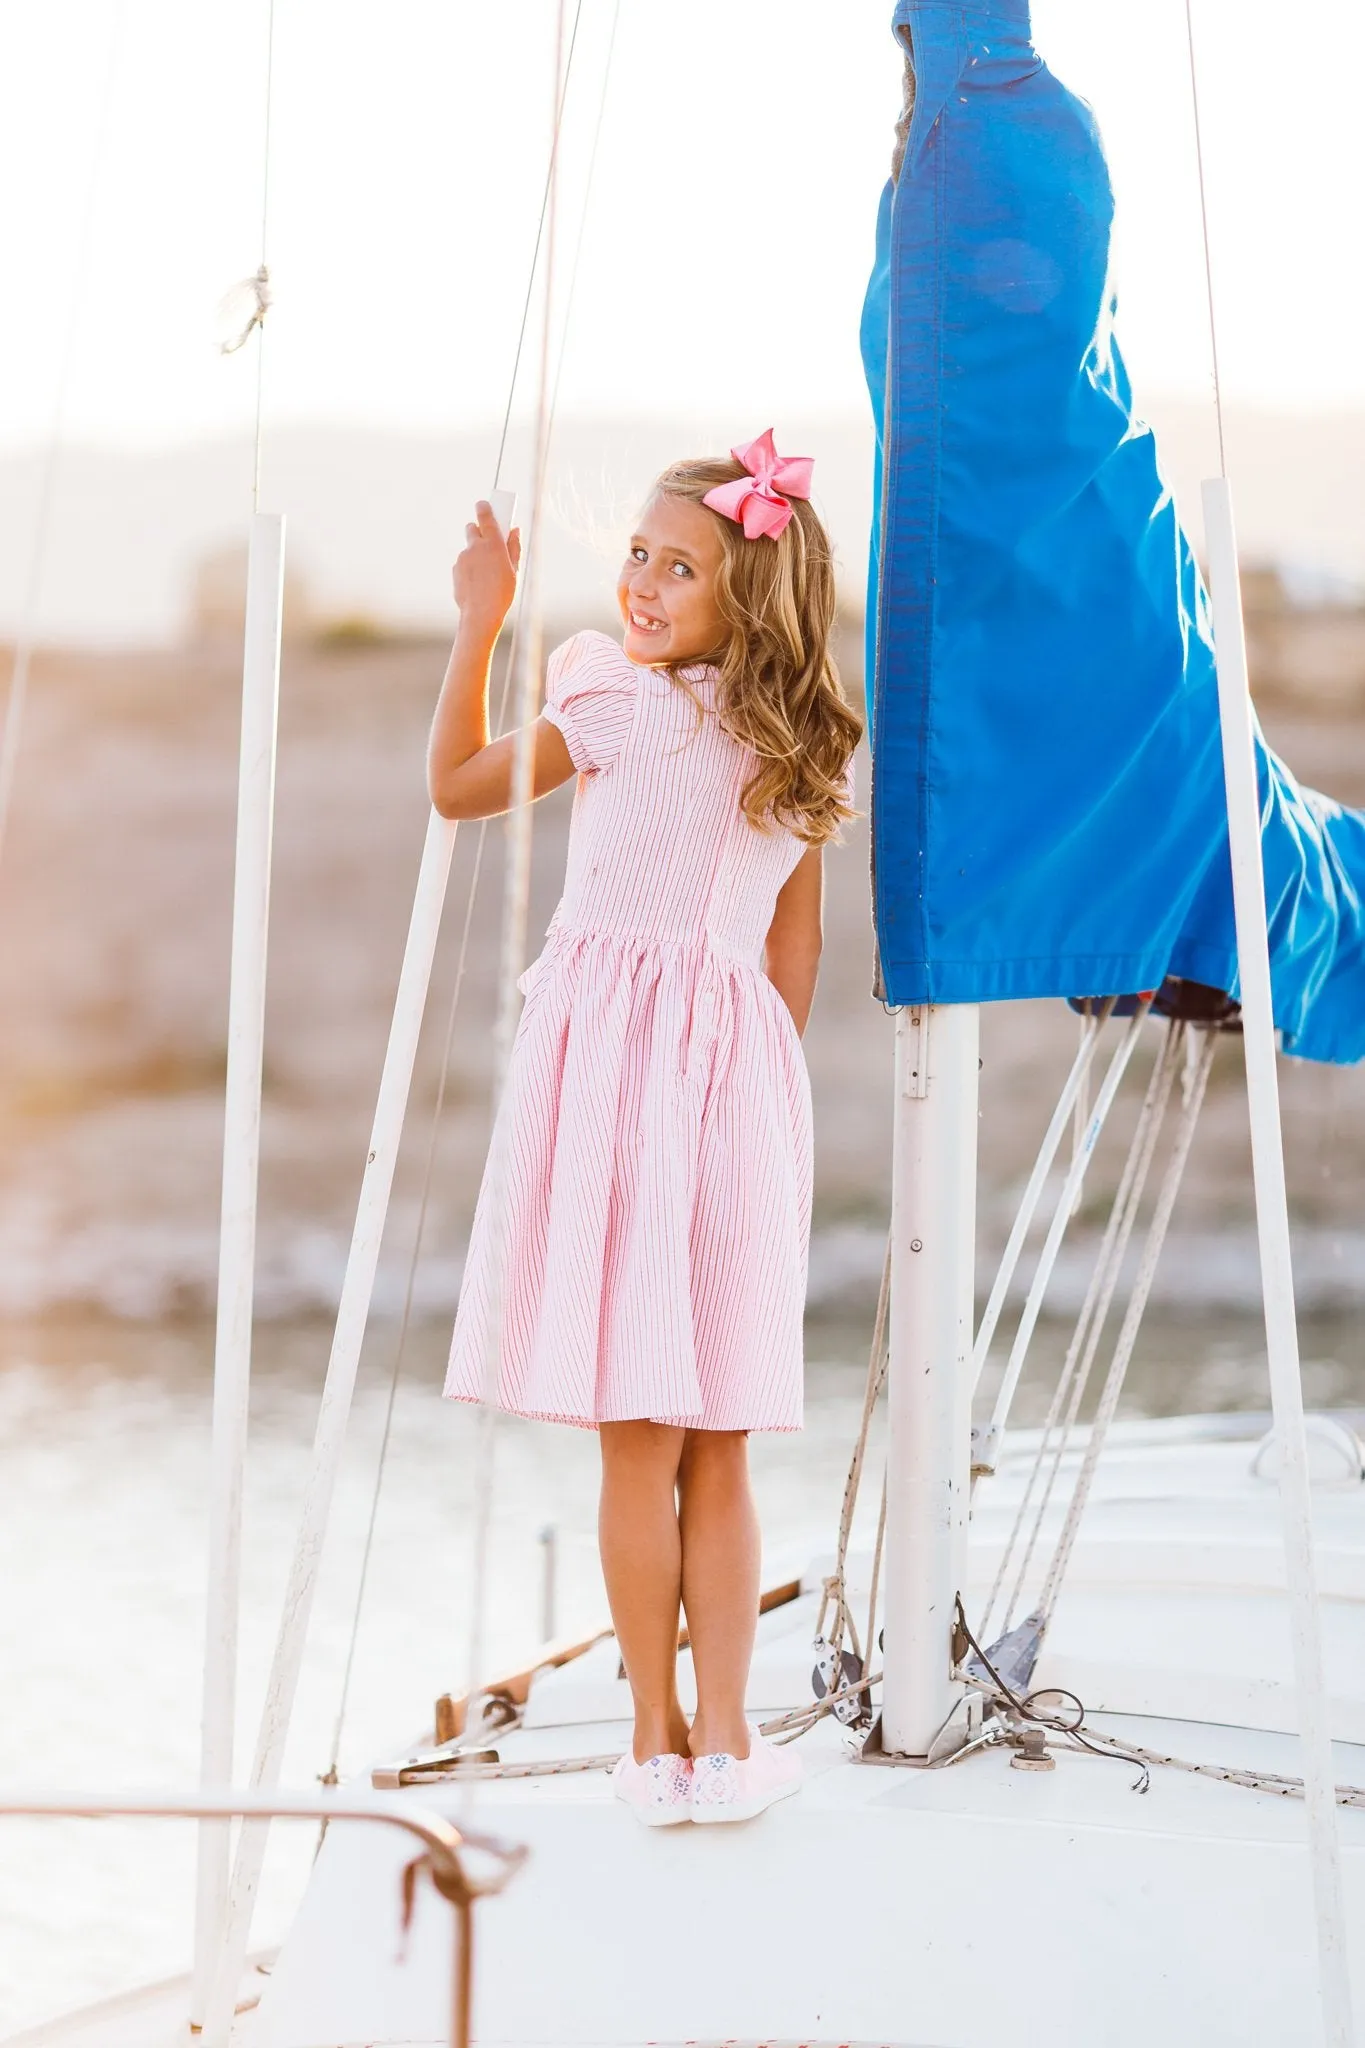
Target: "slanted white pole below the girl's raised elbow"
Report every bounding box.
[205,811,454,2048]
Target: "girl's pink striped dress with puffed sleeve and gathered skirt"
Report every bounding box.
[446,633,810,1430]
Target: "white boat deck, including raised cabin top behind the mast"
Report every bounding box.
[252,1427,1365,2048]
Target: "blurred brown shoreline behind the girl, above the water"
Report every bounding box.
[0,614,1365,1321]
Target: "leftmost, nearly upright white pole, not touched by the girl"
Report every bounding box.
[190,512,284,2025]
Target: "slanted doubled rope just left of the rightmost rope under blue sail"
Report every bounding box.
[982,1022,1185,1632]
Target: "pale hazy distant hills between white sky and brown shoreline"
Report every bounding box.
[0,403,1365,649]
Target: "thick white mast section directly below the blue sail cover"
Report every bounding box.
[882,1004,980,1757]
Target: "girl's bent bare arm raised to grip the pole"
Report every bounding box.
[426,500,575,817]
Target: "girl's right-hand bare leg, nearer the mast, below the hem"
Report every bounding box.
[677,1430,759,1757]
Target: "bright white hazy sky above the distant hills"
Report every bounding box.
[0,0,1365,446]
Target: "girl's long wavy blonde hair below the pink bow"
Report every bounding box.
[655,457,862,846]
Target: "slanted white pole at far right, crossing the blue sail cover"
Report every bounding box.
[1203,477,1355,2048]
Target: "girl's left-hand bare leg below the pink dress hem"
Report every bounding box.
[598,1421,688,1763]
